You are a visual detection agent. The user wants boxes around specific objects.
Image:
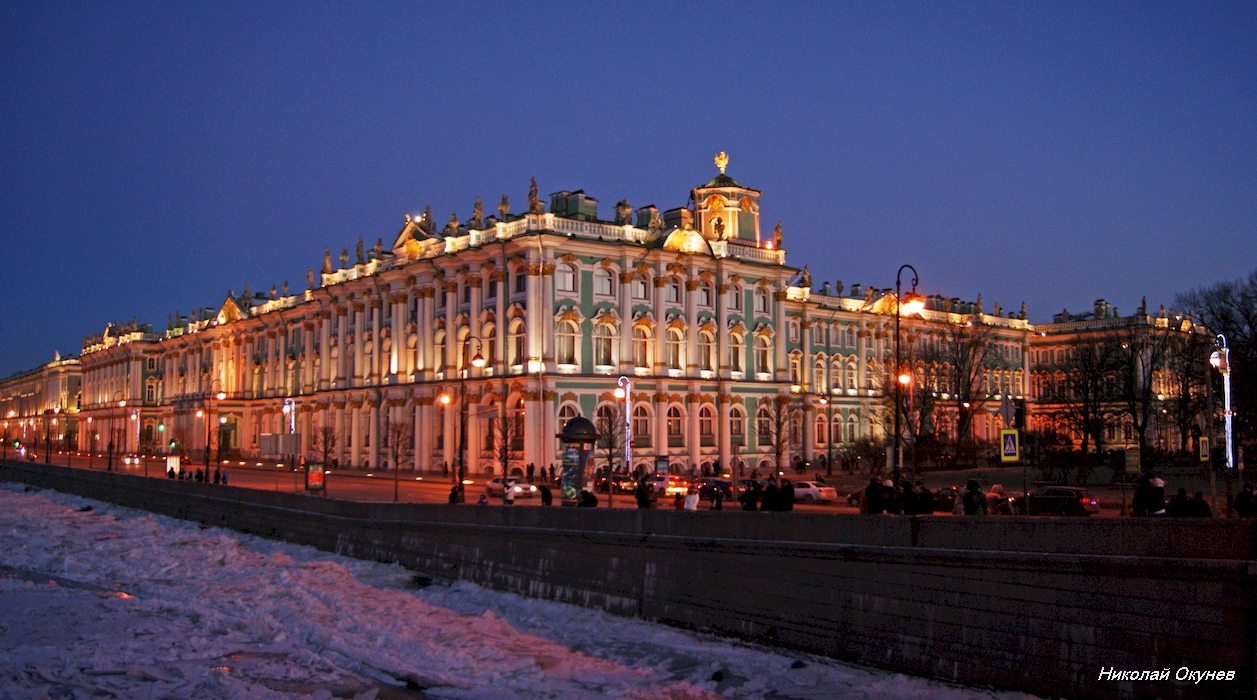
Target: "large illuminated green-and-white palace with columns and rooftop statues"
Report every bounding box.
[61,153,1206,474]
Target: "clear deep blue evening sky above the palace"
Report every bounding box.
[0,3,1257,376]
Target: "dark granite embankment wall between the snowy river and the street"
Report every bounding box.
[0,461,1257,697]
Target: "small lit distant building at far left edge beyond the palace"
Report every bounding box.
[0,353,82,456]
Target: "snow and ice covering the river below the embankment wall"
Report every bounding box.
[0,484,1027,700]
